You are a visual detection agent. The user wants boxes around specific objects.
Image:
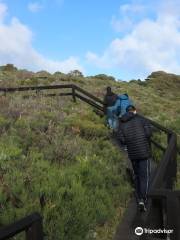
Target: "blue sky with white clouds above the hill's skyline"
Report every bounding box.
[0,0,180,81]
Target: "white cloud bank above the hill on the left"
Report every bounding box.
[0,3,83,73]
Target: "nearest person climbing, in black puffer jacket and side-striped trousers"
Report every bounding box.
[117,105,152,211]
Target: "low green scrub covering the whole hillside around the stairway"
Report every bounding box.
[0,65,180,240]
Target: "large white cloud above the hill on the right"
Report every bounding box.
[86,1,180,77]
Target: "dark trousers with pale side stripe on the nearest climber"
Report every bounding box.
[131,158,151,202]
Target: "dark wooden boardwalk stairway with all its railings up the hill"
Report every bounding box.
[0,84,180,240]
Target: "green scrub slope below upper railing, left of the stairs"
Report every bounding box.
[0,93,131,240]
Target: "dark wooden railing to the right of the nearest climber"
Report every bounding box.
[139,116,180,240]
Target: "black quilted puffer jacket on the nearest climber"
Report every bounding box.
[117,112,152,160]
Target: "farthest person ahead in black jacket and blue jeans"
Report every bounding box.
[104,87,118,129]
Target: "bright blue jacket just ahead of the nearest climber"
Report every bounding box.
[115,93,134,117]
